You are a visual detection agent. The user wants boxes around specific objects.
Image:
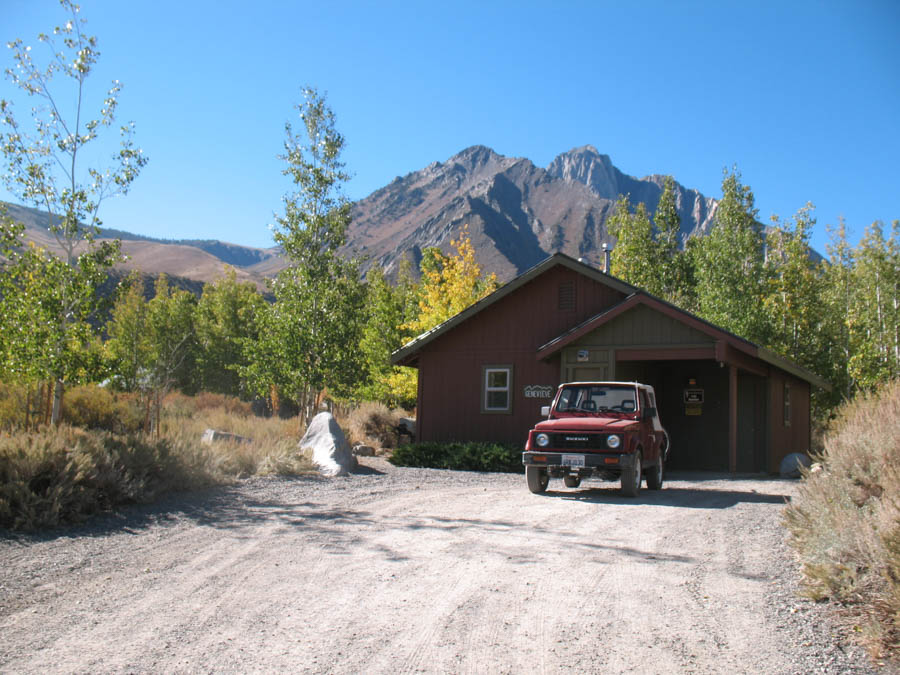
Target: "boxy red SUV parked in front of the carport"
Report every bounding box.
[522,382,669,497]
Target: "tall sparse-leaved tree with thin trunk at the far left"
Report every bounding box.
[0,0,147,424]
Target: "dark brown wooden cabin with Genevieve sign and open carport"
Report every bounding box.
[392,253,828,472]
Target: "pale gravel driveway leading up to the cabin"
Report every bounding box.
[0,459,868,673]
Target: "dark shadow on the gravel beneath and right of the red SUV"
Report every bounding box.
[545,486,791,509]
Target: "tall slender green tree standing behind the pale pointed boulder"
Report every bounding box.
[242,88,365,418]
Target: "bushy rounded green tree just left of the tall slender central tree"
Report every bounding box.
[196,268,267,396]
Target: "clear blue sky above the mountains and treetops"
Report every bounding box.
[0,0,900,252]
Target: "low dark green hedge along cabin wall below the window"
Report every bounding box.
[390,443,524,473]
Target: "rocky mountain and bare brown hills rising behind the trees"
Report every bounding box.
[9,145,717,288]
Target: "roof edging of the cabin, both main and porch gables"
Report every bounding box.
[391,253,831,391]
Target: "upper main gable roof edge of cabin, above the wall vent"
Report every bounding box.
[391,253,639,366]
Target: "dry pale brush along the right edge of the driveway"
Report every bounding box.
[785,381,900,661]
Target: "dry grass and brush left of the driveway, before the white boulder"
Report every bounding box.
[0,392,314,530]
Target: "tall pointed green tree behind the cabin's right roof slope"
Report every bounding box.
[691,170,769,345]
